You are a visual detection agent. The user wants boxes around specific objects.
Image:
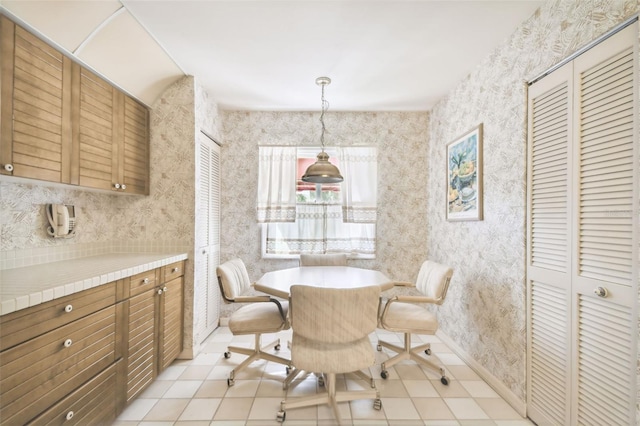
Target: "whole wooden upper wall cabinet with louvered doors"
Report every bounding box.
[0,15,149,194]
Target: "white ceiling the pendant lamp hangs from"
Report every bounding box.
[0,0,543,111]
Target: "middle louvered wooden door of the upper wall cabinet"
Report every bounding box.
[74,64,117,189]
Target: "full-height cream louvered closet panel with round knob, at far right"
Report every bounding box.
[572,24,639,425]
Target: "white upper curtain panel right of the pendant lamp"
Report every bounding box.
[338,146,378,223]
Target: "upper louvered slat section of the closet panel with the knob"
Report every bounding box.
[579,49,634,286]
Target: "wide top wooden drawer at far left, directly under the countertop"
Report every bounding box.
[0,282,116,351]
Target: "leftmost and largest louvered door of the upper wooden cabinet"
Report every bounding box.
[0,16,71,183]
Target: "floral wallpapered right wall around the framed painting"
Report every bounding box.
[426,0,639,401]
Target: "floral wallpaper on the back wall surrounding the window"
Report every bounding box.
[220,111,429,317]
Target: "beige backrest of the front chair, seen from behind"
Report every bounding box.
[289,285,380,344]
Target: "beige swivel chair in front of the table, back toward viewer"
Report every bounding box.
[277,285,382,424]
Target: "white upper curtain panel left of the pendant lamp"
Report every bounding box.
[257,146,298,223]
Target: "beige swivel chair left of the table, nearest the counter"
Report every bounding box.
[216,259,291,386]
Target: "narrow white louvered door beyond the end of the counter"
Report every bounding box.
[194,132,220,343]
